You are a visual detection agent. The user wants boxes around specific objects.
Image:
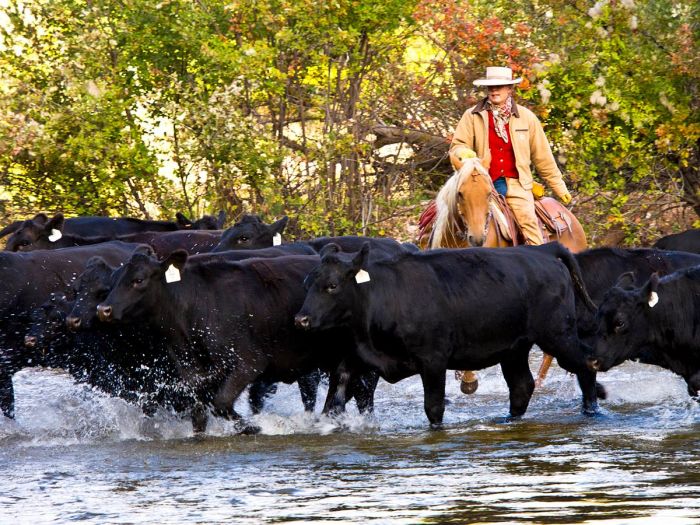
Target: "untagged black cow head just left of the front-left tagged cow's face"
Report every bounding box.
[66,256,116,332]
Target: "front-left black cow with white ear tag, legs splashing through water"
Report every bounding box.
[98,251,370,431]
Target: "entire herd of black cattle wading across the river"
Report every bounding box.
[0,214,700,432]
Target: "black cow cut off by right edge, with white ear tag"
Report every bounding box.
[589,266,700,397]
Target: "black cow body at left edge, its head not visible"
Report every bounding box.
[0,241,142,417]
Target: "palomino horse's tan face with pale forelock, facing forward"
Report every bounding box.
[457,159,493,246]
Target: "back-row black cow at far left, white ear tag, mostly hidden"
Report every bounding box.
[0,213,223,251]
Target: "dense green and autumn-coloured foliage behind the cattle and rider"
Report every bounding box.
[0,0,700,244]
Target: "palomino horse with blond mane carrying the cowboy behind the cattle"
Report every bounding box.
[419,159,587,389]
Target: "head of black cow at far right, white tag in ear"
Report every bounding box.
[588,274,659,372]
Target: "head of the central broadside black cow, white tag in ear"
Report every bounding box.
[294,239,370,330]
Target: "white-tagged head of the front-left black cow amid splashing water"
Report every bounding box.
[97,247,188,322]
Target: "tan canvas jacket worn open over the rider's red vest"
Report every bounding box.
[450,99,567,198]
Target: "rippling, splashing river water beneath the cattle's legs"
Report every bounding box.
[0,354,700,525]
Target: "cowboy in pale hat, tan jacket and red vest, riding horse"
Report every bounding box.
[450,67,571,244]
